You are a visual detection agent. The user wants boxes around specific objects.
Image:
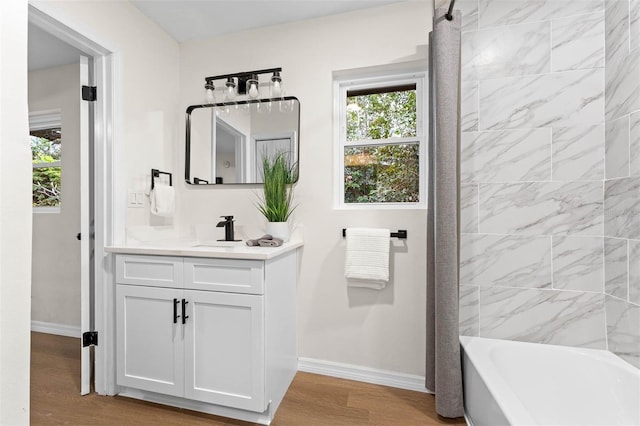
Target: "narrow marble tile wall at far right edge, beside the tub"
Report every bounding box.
[604,0,640,368]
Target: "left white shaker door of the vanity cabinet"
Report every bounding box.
[116,285,184,396]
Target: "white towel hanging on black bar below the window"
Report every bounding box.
[344,228,391,290]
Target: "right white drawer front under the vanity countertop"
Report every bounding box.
[184,258,264,294]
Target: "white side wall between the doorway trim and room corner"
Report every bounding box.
[31,0,184,232]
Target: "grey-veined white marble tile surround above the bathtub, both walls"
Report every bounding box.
[456,0,640,360]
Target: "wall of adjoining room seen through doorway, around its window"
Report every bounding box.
[29,63,80,328]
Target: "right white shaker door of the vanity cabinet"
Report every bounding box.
[184,290,266,412]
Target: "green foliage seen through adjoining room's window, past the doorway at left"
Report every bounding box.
[30,128,62,207]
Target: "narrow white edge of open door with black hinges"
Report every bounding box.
[79,56,94,395]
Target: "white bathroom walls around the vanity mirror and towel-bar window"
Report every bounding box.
[27,0,432,380]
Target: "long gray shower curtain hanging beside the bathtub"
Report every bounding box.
[426,8,464,417]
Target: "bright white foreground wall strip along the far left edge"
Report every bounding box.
[0,0,31,425]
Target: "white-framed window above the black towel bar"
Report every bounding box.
[336,73,426,208]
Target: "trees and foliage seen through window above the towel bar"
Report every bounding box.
[344,88,420,203]
